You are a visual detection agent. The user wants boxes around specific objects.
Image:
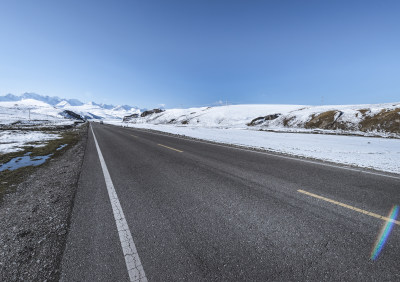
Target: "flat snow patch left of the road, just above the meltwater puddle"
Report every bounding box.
[0,130,61,154]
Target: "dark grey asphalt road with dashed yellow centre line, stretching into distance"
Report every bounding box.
[61,123,400,281]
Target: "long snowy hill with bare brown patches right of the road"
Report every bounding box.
[122,103,400,137]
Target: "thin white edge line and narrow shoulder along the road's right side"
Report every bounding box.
[123,127,400,180]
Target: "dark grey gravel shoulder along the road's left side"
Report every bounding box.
[0,126,88,281]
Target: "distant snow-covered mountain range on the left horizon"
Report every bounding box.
[0,93,141,123]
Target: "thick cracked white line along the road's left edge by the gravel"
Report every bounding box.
[90,126,147,282]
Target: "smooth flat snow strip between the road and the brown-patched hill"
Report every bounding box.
[106,121,400,173]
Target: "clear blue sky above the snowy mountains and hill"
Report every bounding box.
[0,0,400,108]
